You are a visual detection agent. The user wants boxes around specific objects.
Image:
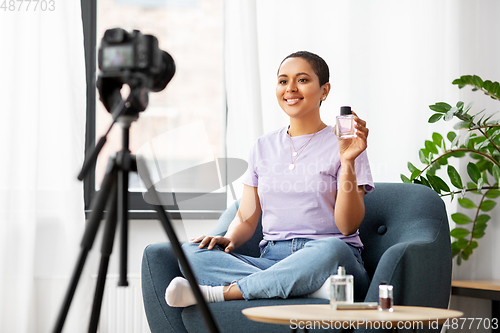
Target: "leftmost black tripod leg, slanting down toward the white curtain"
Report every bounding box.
[53,160,116,333]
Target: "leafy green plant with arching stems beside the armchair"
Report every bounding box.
[401,75,500,265]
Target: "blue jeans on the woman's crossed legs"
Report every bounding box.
[181,237,370,301]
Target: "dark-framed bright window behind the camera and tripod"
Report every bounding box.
[82,0,226,218]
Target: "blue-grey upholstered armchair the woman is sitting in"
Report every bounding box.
[142,183,452,333]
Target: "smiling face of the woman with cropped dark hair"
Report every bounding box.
[276,58,330,118]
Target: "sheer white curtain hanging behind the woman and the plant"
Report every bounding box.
[225,0,500,320]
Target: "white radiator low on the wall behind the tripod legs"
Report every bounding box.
[92,275,151,333]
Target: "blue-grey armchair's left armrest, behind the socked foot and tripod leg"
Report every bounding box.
[141,243,187,333]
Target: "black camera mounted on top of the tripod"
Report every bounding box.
[97,28,175,112]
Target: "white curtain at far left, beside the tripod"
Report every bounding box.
[0,1,88,333]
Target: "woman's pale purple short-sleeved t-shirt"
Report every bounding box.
[242,126,374,249]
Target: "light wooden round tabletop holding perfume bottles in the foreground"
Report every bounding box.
[242,304,463,332]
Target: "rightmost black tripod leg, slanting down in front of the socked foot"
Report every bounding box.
[136,158,219,333]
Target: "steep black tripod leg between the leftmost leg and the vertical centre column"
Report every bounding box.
[88,180,117,333]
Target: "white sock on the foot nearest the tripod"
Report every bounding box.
[165,276,224,307]
